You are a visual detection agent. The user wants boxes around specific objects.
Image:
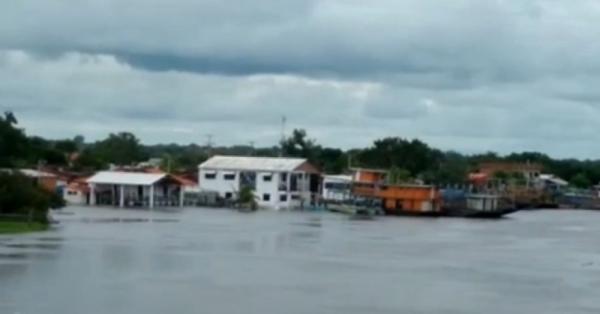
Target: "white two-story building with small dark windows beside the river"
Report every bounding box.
[198,156,319,209]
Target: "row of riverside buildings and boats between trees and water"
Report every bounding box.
[10,146,600,219]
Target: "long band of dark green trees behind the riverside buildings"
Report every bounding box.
[0,113,600,188]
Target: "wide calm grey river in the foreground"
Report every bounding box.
[0,207,600,314]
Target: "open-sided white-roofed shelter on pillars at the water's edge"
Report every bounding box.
[86,171,184,208]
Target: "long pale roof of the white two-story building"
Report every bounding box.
[199,156,306,172]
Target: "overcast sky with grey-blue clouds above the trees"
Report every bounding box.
[0,0,600,159]
